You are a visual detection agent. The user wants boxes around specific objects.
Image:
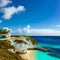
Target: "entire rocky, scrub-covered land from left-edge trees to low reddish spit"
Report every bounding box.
[0,28,48,60]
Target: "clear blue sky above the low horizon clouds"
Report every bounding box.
[0,0,60,35]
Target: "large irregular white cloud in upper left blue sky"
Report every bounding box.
[1,6,25,19]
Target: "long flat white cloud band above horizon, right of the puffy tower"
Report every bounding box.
[30,29,60,36]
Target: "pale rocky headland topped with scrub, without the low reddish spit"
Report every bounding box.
[9,36,37,51]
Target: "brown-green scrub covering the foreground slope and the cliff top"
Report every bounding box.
[0,36,37,60]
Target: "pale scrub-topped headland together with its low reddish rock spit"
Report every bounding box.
[10,36,48,54]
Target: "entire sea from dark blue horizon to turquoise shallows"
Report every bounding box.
[31,36,60,60]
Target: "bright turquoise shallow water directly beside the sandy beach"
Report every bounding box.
[34,51,60,60]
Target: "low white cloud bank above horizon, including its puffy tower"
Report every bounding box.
[19,25,60,36]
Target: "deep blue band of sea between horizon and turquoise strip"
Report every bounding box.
[32,36,60,45]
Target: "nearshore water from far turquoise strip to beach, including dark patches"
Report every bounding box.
[33,44,60,60]
